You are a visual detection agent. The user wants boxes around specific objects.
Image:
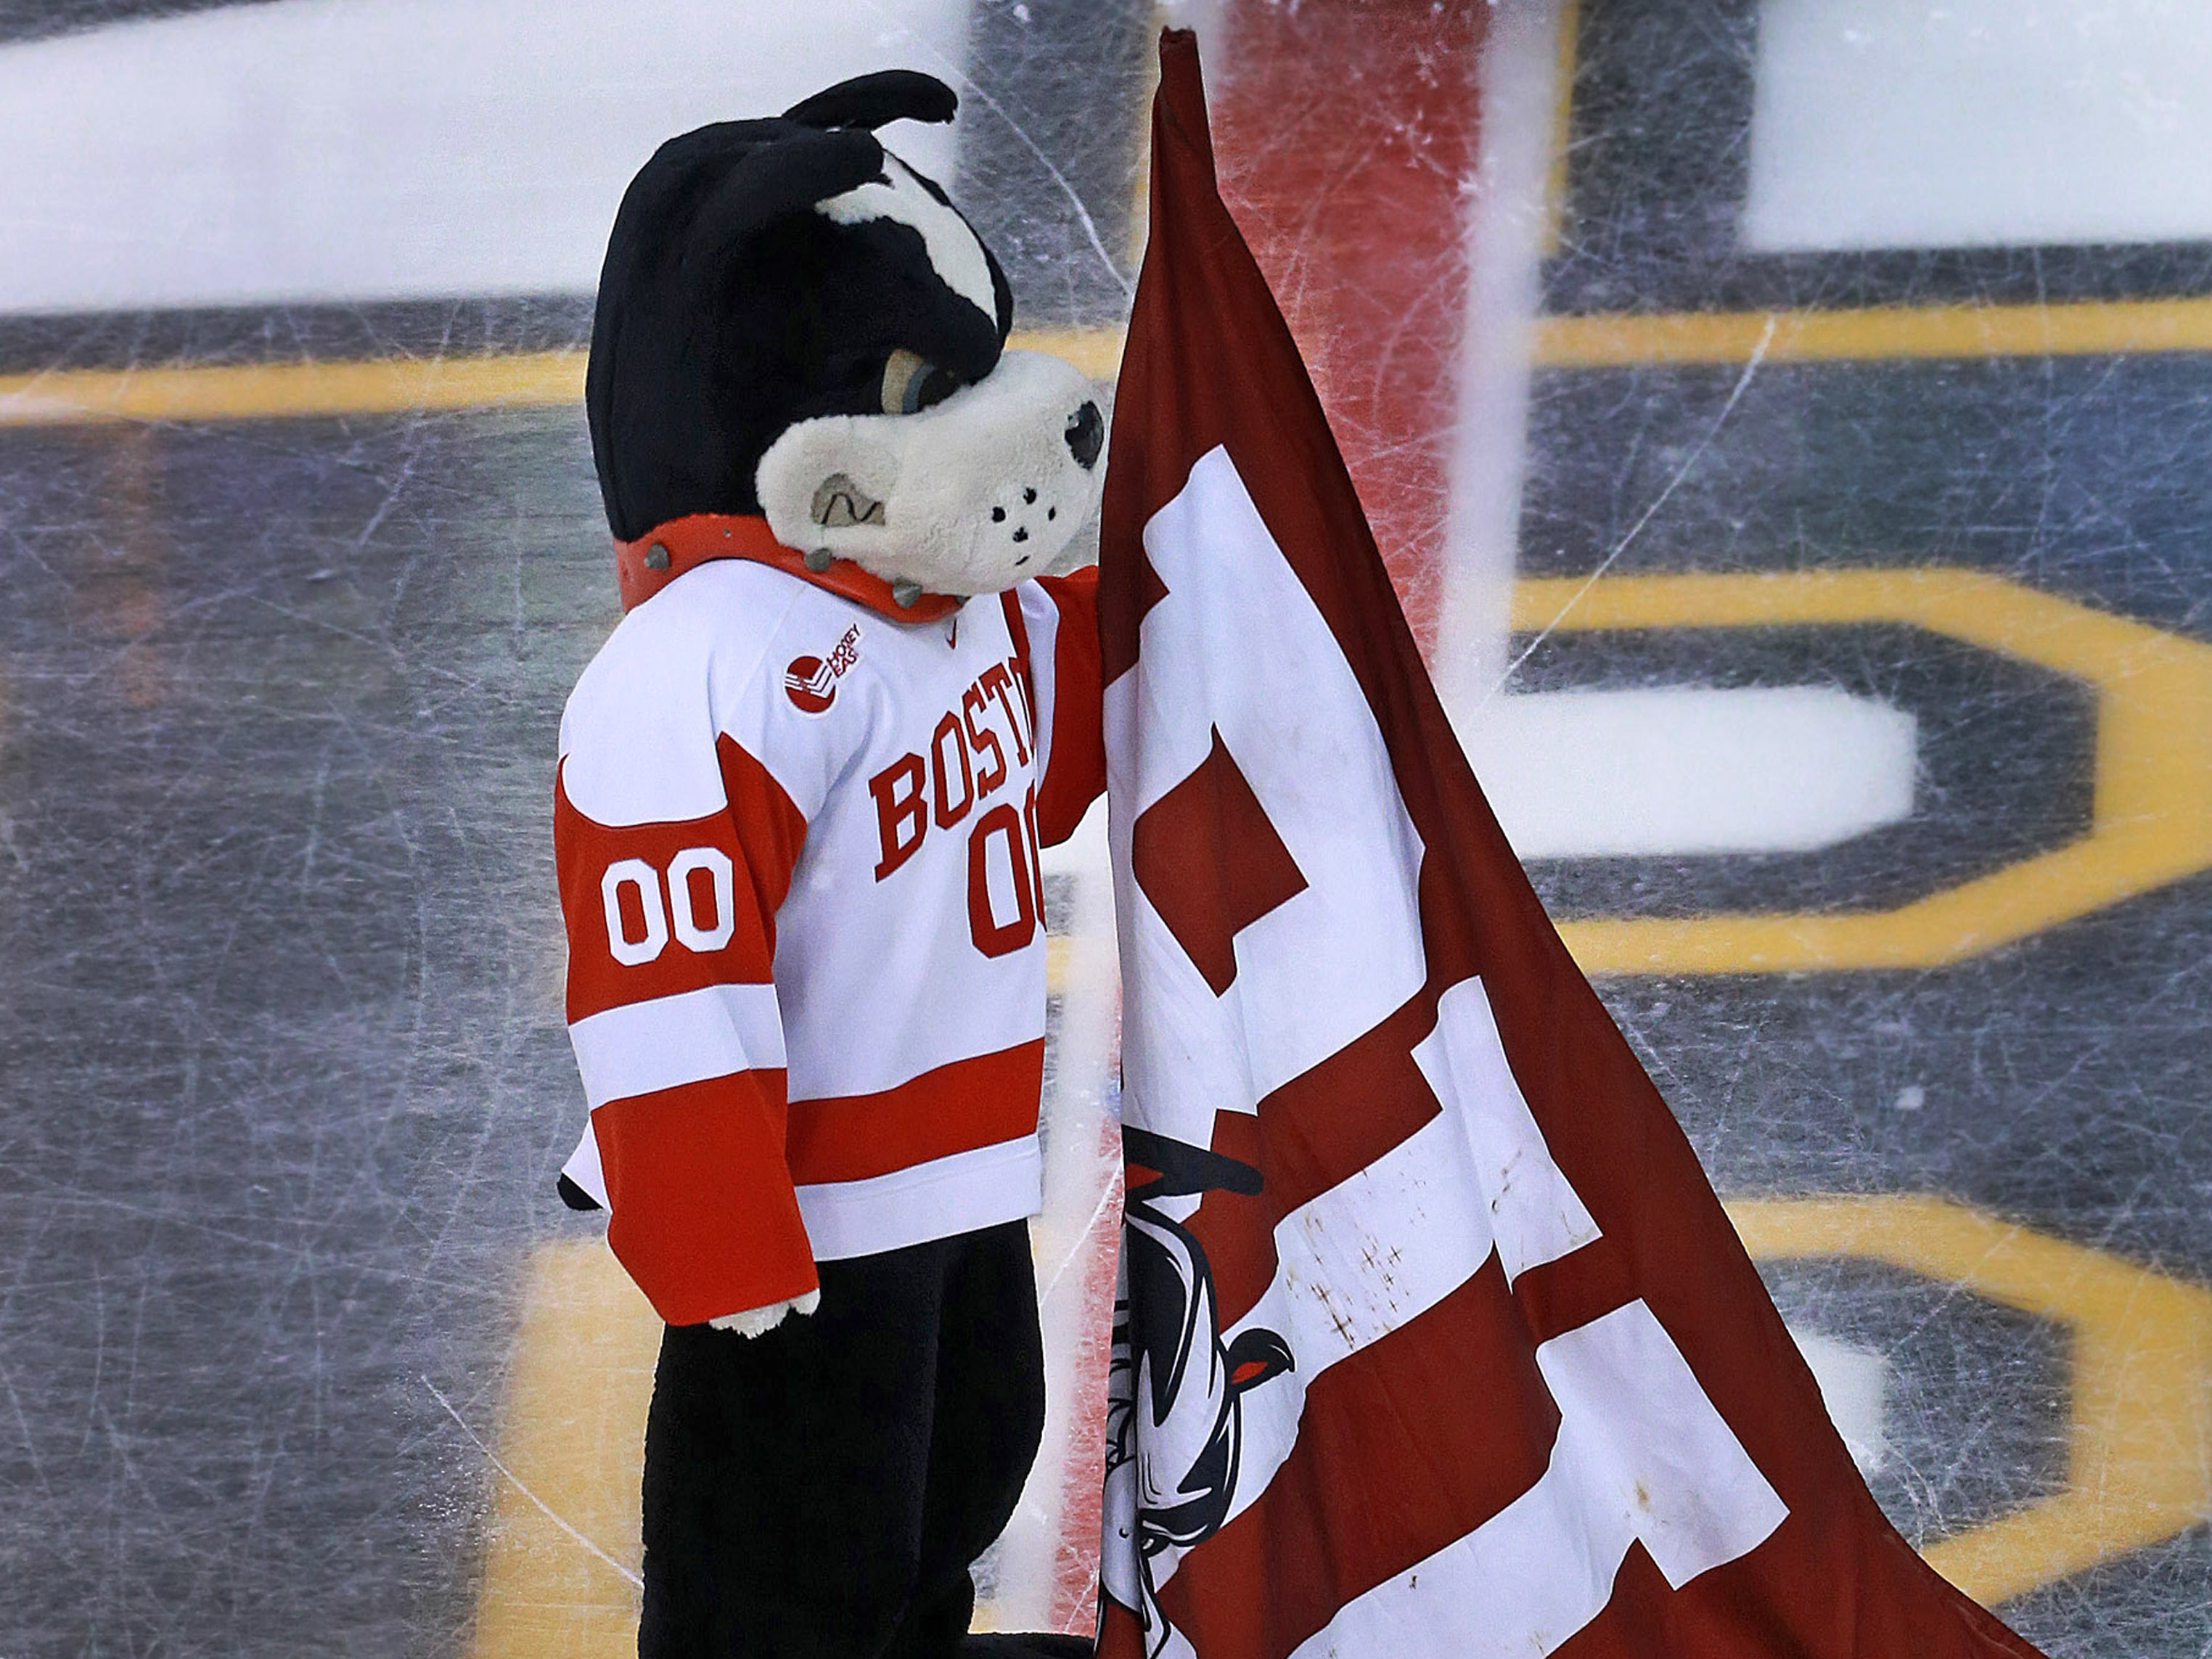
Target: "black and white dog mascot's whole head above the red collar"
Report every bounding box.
[584,71,1106,604]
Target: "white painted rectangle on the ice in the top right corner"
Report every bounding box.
[1743,0,2212,252]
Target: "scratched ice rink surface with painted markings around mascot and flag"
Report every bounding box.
[0,0,2212,1659]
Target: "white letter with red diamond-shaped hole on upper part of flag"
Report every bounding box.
[1104,449,1427,1146]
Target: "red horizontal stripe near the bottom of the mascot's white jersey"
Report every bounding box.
[785,1038,1044,1186]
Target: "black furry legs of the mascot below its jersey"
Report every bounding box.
[637,1221,1089,1659]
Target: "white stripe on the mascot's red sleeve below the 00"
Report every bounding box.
[568,984,783,1108]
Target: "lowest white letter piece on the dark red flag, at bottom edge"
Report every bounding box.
[1294,1300,1787,1659]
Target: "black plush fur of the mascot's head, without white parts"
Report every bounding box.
[584,71,1013,542]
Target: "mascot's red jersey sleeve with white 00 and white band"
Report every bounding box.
[553,737,816,1330]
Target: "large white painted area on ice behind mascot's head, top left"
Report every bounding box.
[0,0,969,312]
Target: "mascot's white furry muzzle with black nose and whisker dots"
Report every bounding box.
[756,352,1106,595]
